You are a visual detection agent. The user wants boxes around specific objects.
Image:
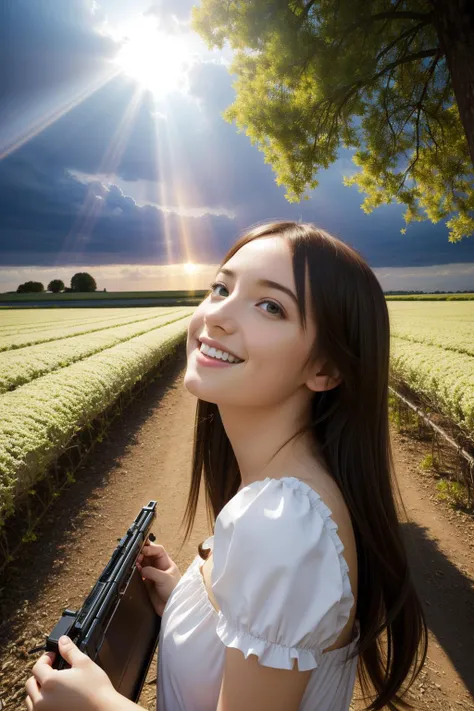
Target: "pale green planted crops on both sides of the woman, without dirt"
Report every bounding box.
[0,294,474,548]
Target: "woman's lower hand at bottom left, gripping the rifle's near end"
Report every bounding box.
[26,637,121,711]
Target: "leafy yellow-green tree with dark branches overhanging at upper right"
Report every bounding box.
[192,0,474,242]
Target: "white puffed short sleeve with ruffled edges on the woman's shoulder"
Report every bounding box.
[211,477,354,671]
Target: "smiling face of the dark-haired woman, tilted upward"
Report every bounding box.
[184,236,316,408]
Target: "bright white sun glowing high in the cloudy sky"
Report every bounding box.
[115,19,191,97]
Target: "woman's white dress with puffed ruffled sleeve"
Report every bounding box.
[157,476,360,711]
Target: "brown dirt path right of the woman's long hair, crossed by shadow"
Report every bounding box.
[380,428,474,711]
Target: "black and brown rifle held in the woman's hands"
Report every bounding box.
[28,501,161,702]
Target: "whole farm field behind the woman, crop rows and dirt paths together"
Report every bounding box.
[0,299,474,711]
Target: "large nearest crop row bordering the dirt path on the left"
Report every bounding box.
[0,316,190,527]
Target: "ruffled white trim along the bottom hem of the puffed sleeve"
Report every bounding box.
[216,612,322,671]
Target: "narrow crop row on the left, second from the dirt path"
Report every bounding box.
[0,308,192,393]
